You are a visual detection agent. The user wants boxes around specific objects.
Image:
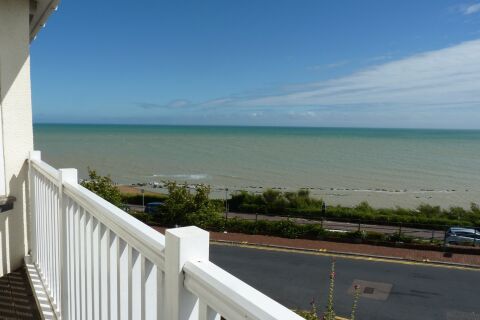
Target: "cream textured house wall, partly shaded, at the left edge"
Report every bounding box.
[0,0,33,276]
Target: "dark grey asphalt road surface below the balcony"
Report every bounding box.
[210,245,480,320]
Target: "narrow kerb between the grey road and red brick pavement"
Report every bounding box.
[211,240,480,270]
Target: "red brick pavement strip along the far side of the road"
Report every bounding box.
[153,227,480,267]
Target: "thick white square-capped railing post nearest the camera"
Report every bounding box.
[164,227,209,320]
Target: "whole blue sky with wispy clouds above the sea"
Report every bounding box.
[31,0,480,129]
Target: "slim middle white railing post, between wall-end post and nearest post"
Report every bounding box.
[58,169,78,319]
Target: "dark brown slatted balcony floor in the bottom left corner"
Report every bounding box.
[0,267,40,319]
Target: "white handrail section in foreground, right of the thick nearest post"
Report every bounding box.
[183,261,303,320]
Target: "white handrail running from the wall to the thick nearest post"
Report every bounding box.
[30,159,165,270]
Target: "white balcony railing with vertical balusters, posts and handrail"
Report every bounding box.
[29,151,303,320]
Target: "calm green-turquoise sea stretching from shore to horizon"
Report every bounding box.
[34,124,480,208]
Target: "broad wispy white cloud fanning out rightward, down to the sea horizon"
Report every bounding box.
[149,39,480,128]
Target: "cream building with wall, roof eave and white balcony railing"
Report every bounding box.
[0,0,302,320]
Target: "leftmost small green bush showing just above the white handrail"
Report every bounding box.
[81,168,122,207]
